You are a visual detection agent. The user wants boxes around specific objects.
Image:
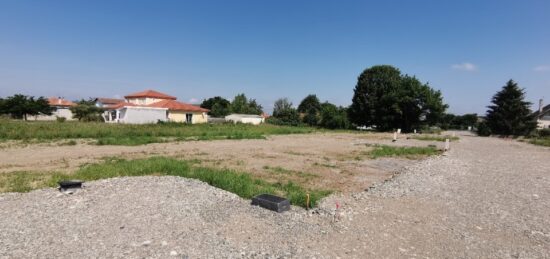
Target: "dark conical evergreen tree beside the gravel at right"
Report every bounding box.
[486,79,537,136]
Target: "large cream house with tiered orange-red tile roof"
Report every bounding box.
[104,90,208,124]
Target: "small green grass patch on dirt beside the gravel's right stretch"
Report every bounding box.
[367,145,441,159]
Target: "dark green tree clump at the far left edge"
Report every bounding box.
[0,94,55,120]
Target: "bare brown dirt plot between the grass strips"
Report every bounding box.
[0,133,442,192]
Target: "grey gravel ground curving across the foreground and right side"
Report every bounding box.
[0,136,550,258]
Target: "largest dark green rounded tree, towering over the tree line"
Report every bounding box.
[349,65,447,132]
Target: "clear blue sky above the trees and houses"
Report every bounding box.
[0,0,550,114]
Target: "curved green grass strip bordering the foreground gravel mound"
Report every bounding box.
[0,157,331,207]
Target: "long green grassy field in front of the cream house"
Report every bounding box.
[0,120,316,145]
